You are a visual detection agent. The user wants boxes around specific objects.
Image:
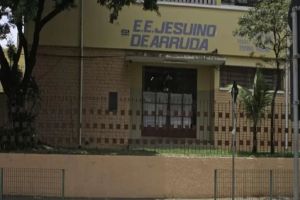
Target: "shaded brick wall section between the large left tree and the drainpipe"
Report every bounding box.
[34,47,80,145]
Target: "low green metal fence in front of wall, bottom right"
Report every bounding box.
[214,169,293,200]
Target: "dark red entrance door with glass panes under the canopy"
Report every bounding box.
[142,67,197,137]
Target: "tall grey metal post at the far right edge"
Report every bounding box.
[292,7,299,200]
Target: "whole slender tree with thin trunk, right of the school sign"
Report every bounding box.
[234,0,291,153]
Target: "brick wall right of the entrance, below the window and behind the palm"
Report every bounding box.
[214,89,292,152]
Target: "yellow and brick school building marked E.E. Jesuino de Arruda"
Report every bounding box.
[17,0,291,151]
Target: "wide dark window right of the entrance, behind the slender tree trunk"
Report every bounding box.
[220,66,283,90]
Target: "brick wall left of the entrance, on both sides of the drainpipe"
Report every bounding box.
[34,47,130,147]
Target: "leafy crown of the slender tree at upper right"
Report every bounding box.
[234,0,290,55]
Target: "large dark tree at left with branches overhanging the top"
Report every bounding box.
[0,0,158,149]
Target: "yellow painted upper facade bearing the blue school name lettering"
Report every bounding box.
[37,1,273,59]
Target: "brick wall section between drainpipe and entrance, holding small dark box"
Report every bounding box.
[83,49,130,147]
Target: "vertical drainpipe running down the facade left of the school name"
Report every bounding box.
[78,0,83,148]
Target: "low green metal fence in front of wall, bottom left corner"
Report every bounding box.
[0,168,65,200]
